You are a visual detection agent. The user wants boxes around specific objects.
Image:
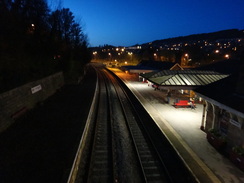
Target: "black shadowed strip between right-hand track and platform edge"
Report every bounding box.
[108,67,199,183]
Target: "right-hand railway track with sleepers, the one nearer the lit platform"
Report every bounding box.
[107,69,173,182]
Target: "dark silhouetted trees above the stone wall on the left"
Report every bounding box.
[0,0,91,92]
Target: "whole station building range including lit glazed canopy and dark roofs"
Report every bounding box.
[124,60,244,158]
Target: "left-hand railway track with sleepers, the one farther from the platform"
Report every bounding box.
[87,68,114,182]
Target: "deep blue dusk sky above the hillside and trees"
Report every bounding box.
[48,0,244,46]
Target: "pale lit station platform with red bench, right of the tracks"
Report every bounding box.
[110,68,244,183]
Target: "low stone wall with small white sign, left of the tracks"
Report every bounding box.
[0,72,64,133]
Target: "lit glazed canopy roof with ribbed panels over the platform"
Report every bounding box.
[140,70,229,89]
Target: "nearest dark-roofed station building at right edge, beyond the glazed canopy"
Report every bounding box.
[194,69,244,152]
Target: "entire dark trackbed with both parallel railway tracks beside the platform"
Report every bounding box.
[69,64,196,183]
